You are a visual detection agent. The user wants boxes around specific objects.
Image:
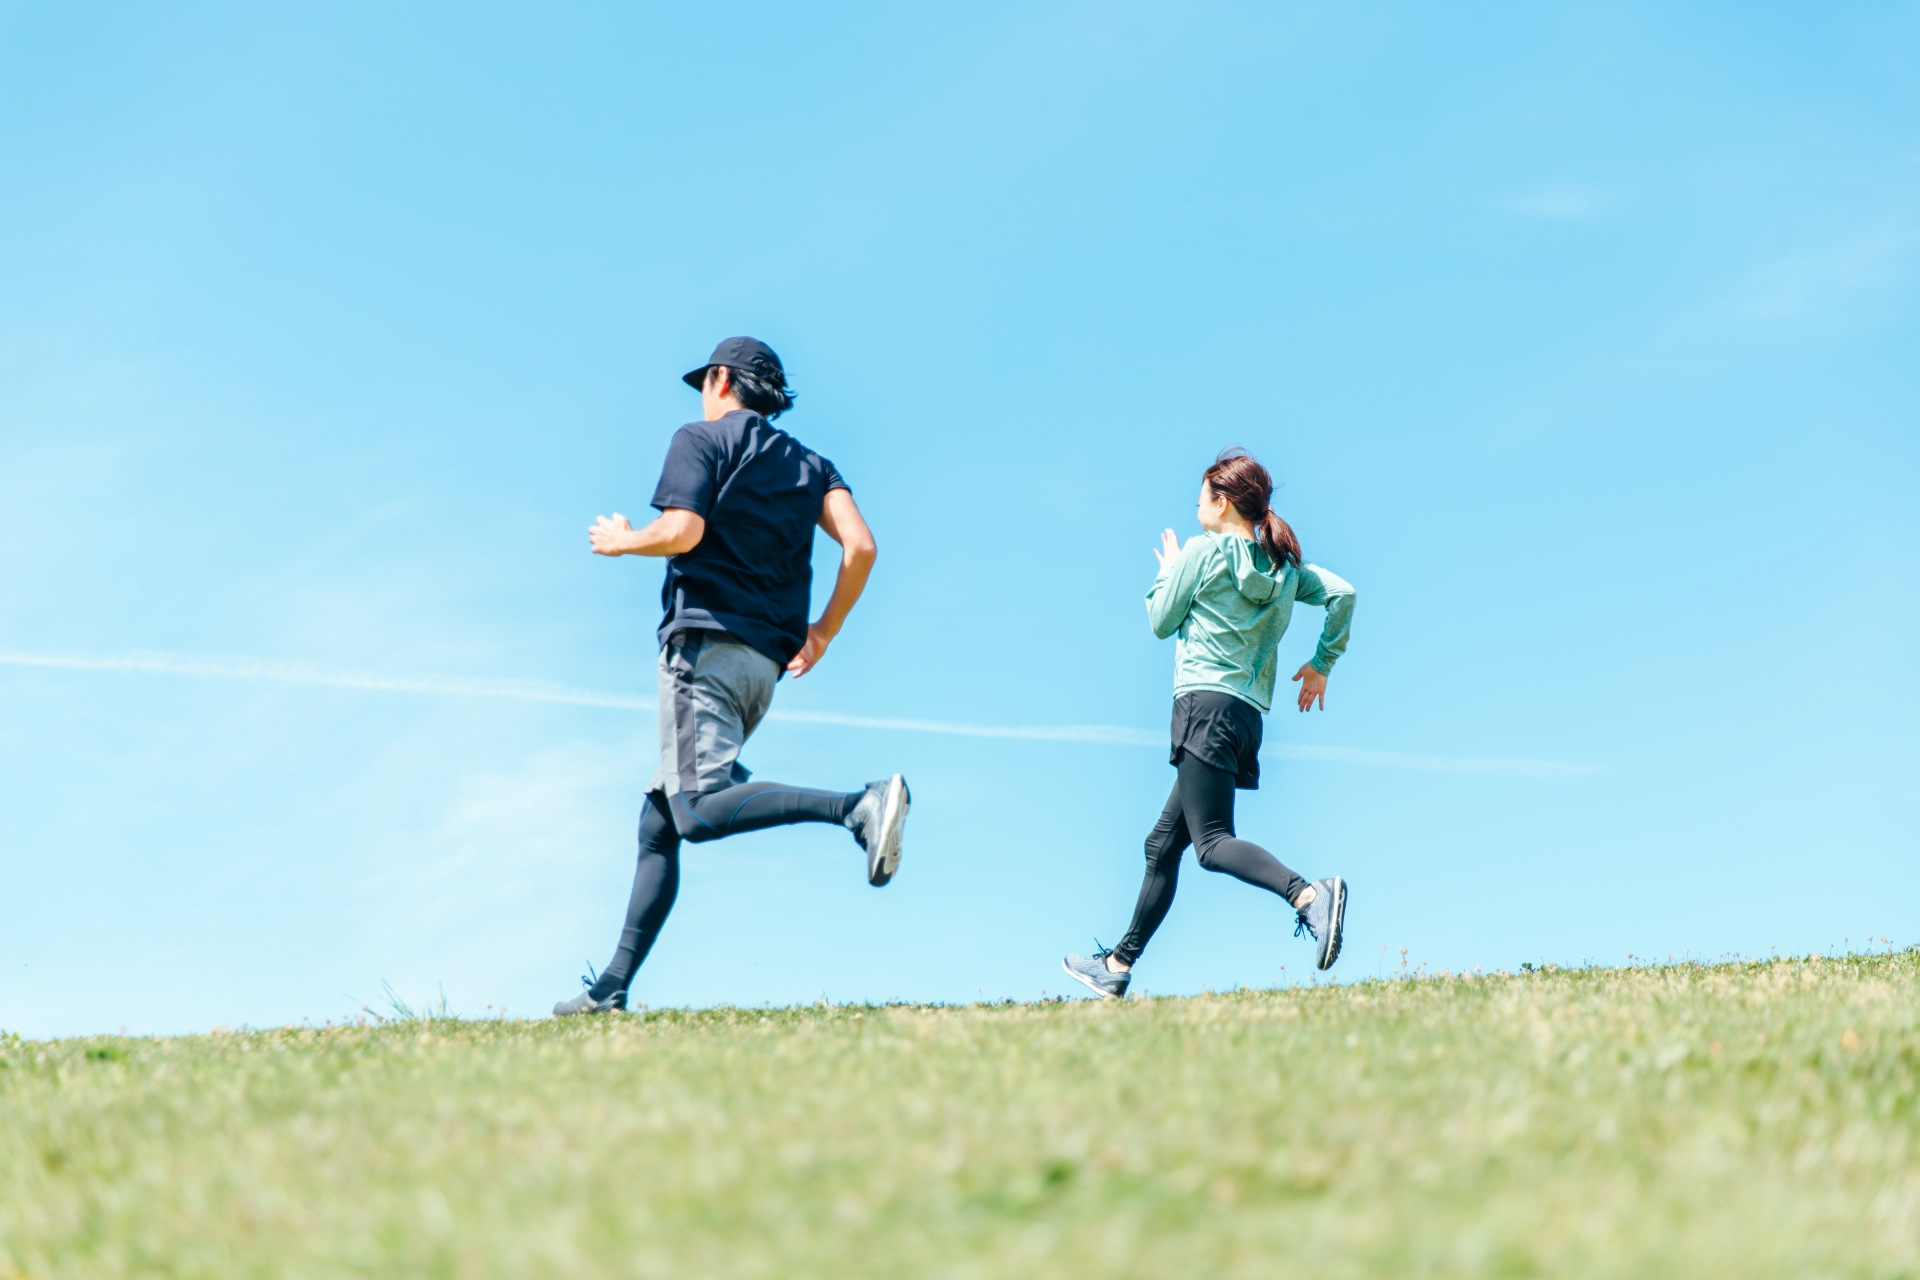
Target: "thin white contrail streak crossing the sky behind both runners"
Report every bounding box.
[0,649,1601,777]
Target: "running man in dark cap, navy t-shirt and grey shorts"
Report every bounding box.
[553,338,910,1017]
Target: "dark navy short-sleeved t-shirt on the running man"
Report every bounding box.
[653,409,847,666]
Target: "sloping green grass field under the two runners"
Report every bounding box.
[0,954,1920,1280]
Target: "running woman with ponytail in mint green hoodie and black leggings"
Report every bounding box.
[1062,449,1354,1000]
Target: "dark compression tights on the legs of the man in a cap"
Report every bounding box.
[591,783,862,1000]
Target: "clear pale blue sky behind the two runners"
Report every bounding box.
[0,4,1920,1034]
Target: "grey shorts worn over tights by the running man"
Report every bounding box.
[647,631,780,796]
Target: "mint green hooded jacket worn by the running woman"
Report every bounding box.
[1146,533,1354,712]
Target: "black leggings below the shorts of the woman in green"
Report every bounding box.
[1114,752,1308,965]
